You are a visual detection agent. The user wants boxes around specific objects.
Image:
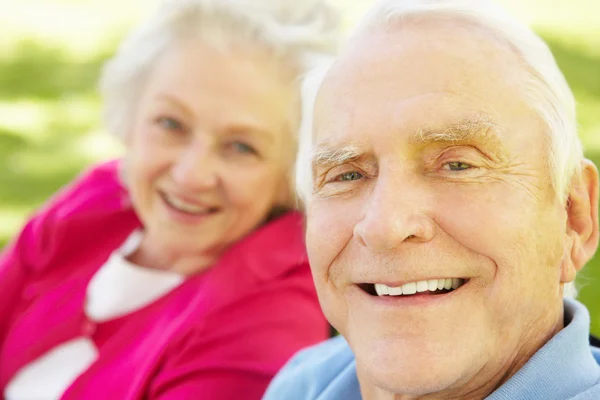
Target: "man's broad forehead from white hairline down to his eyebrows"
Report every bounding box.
[313,13,531,161]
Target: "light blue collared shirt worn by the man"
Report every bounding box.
[263,299,600,400]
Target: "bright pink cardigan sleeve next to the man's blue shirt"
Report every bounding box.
[148,265,328,400]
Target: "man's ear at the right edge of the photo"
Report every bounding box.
[561,160,598,283]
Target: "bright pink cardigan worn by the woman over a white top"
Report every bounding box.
[0,162,328,400]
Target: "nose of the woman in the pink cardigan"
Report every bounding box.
[171,140,219,191]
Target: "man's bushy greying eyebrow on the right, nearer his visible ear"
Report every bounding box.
[412,114,501,146]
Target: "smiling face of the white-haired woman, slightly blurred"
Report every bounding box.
[125,40,297,272]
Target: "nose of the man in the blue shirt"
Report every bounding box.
[354,179,436,252]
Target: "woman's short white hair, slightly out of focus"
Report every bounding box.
[100,0,338,137]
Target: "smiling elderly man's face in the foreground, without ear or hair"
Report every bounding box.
[307,19,568,398]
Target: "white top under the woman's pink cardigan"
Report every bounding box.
[4,231,185,400]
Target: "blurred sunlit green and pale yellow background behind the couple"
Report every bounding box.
[0,0,600,335]
